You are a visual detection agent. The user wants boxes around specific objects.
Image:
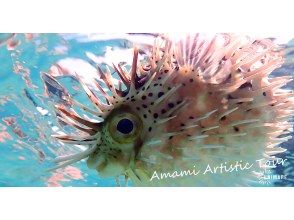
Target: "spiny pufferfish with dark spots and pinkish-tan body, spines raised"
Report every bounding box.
[49,34,294,186]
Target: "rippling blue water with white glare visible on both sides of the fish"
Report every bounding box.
[0,34,294,187]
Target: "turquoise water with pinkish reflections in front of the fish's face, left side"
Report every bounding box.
[0,34,133,186]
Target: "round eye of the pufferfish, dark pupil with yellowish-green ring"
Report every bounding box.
[105,110,143,144]
